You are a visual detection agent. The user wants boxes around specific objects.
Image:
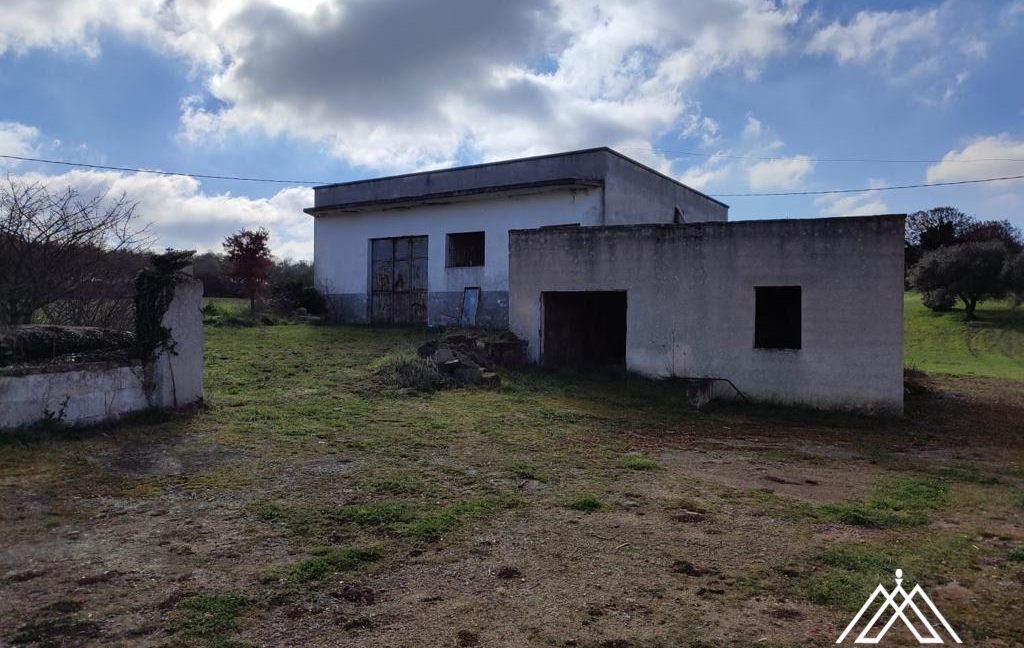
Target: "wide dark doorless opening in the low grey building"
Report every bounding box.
[543,291,626,369]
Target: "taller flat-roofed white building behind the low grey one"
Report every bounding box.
[306,148,729,328]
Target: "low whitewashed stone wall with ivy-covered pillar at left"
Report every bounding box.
[0,279,203,429]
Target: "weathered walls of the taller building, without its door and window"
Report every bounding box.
[313,148,728,328]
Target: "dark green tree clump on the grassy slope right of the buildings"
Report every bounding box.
[904,207,1024,319]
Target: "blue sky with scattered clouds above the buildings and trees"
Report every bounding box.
[0,0,1024,259]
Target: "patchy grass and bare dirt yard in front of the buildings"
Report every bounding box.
[0,325,1024,648]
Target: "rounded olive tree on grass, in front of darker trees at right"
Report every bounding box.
[910,241,1008,319]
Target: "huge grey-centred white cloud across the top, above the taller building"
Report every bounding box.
[0,0,803,169]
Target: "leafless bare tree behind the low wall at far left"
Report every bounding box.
[0,177,151,325]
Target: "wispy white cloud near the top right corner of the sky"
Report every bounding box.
[807,9,939,63]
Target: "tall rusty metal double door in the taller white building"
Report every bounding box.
[370,236,427,325]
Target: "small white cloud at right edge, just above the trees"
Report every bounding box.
[926,133,1024,184]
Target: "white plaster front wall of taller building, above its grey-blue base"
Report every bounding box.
[313,188,601,295]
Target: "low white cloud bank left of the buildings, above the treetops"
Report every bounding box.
[13,170,313,259]
